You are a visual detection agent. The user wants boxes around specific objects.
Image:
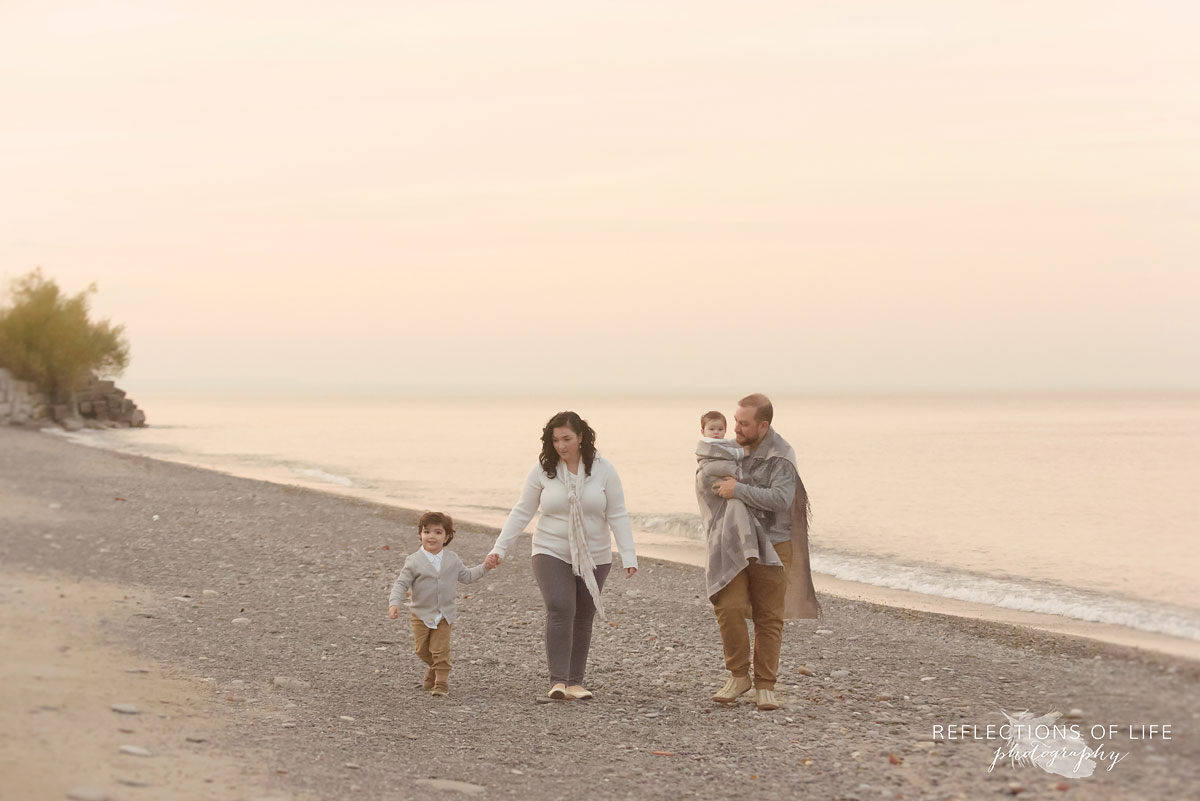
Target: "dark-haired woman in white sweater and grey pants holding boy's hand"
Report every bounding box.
[485,411,637,700]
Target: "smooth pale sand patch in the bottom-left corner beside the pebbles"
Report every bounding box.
[0,572,290,801]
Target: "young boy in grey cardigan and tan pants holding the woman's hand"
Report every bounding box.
[388,512,490,695]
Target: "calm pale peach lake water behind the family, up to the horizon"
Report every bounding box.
[63,395,1200,640]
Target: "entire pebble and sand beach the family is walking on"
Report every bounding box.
[0,430,1200,801]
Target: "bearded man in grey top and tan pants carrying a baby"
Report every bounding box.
[713,393,821,710]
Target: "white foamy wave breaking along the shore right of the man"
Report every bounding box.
[812,549,1200,640]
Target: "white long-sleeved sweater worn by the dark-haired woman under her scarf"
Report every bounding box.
[492,456,637,567]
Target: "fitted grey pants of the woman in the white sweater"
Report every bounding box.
[533,554,612,685]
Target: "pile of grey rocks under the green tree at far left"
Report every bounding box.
[0,368,146,430]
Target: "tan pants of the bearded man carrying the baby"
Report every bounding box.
[713,542,792,689]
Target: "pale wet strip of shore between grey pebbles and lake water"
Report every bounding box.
[49,429,1200,662]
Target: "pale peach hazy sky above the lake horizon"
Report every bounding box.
[0,0,1200,396]
